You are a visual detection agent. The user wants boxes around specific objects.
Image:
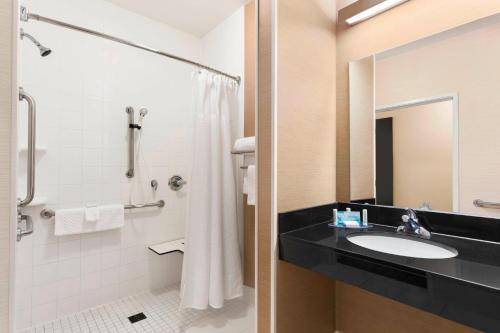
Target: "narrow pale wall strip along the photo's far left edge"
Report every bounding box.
[0,1,14,333]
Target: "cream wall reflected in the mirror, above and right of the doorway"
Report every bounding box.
[375,15,500,216]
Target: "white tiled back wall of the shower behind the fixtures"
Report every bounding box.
[16,0,243,329]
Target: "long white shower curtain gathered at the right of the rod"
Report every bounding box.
[181,70,243,309]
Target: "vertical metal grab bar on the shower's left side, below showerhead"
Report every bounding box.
[17,87,36,207]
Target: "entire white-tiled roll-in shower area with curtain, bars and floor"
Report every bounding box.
[14,0,255,333]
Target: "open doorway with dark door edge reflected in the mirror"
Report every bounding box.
[375,100,453,211]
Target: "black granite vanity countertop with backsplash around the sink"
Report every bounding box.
[279,204,500,332]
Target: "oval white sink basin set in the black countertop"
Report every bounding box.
[347,232,458,259]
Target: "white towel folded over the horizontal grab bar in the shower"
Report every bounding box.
[54,205,125,236]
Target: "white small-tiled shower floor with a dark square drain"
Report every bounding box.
[20,286,255,333]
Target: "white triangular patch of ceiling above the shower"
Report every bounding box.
[107,0,248,37]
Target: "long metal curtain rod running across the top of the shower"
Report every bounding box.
[21,6,241,84]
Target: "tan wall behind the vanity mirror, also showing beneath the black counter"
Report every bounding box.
[336,0,500,333]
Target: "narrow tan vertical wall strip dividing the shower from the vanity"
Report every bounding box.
[255,0,274,333]
